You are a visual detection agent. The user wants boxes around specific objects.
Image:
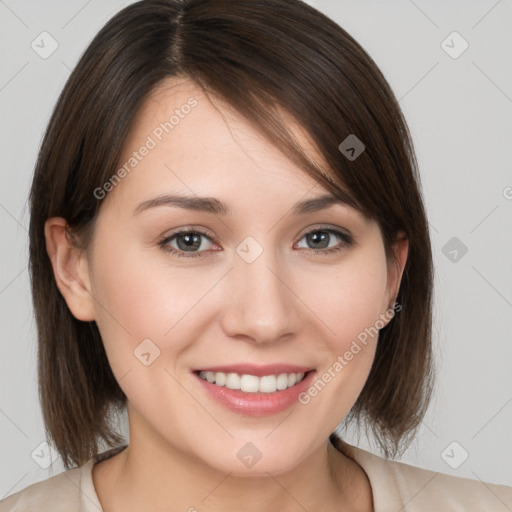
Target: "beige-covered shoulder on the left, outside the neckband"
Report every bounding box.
[0,466,84,512]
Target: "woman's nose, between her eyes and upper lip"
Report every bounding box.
[221,242,305,344]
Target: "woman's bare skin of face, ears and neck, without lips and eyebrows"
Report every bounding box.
[46,81,408,512]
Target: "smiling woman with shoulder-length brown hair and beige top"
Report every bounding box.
[0,0,512,512]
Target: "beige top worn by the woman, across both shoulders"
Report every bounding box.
[0,440,512,512]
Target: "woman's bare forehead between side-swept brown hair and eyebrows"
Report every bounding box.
[108,78,338,205]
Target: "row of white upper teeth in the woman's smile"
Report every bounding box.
[199,371,305,393]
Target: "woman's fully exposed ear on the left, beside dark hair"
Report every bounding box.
[44,217,94,322]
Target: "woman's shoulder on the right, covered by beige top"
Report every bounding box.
[335,441,512,512]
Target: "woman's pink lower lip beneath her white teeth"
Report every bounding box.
[194,370,316,416]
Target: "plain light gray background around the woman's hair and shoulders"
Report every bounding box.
[0,0,512,499]
